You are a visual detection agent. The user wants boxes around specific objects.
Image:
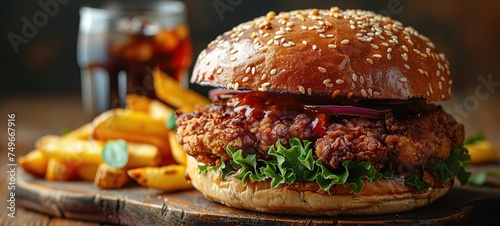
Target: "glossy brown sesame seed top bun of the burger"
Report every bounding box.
[191,7,452,101]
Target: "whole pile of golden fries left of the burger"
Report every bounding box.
[19,70,208,192]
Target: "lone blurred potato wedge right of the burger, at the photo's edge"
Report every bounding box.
[465,140,499,164]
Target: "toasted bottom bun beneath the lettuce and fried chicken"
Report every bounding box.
[187,156,452,216]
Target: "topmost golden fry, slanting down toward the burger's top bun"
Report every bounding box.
[153,68,209,110]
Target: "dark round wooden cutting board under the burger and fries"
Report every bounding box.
[16,169,500,226]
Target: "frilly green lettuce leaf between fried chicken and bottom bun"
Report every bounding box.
[199,138,470,193]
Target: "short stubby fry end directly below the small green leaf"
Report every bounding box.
[94,163,129,189]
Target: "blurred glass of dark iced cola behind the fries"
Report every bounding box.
[77,0,192,119]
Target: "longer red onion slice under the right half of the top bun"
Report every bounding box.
[304,105,391,119]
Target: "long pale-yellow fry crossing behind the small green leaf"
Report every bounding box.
[35,135,162,168]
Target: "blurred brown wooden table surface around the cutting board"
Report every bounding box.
[0,94,500,226]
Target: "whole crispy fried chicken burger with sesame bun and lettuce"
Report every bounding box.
[176,7,469,216]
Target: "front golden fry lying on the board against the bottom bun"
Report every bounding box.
[127,165,193,192]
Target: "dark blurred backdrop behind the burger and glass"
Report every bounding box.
[0,0,500,98]
